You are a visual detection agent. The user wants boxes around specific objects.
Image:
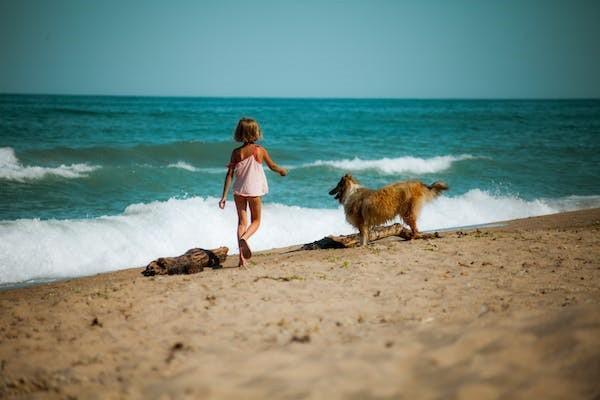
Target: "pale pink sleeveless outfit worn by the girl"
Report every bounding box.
[229,145,269,197]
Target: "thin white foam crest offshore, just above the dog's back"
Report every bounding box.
[304,154,478,175]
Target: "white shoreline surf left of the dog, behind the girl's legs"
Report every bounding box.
[0,198,351,283]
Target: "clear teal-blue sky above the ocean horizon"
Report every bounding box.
[0,0,600,98]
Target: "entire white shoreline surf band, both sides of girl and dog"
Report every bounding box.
[0,190,600,283]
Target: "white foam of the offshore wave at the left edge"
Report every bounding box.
[0,147,100,182]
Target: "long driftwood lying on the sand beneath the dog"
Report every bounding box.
[302,223,440,250]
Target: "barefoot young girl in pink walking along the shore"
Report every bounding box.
[219,118,287,268]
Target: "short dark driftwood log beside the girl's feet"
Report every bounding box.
[142,247,229,276]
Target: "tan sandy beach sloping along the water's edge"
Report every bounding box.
[0,209,600,399]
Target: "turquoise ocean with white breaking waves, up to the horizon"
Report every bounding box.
[0,95,600,286]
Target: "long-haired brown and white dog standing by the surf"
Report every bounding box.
[329,174,448,246]
